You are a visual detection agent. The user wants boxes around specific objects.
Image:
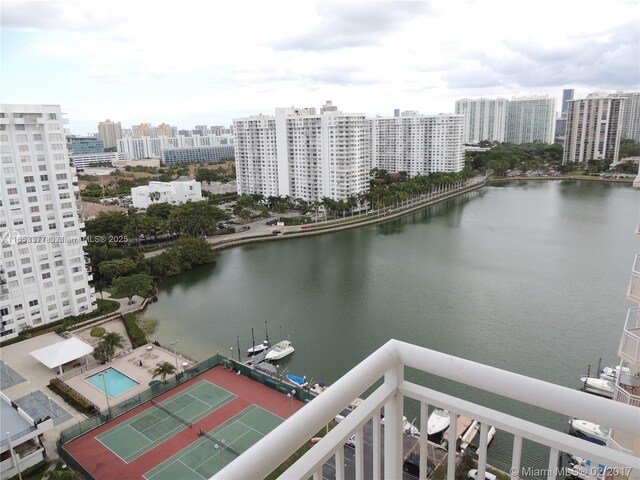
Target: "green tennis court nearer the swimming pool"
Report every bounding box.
[96,380,236,463]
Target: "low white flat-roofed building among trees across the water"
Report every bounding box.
[131,177,203,209]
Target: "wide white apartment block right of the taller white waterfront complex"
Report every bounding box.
[369,111,466,177]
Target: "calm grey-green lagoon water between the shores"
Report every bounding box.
[139,181,638,468]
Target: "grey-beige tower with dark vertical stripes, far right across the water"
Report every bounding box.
[562,93,626,164]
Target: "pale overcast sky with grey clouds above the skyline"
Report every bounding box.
[0,0,640,134]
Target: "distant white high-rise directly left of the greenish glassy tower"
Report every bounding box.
[456,98,509,143]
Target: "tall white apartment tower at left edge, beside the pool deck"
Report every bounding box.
[0,105,96,338]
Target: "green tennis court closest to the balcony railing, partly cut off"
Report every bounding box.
[144,405,283,480]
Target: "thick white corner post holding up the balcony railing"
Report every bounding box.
[384,362,404,478]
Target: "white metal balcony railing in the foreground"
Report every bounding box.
[213,340,640,480]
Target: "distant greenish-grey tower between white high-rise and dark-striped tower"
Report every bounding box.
[506,96,556,144]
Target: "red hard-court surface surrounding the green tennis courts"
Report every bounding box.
[65,365,304,480]
